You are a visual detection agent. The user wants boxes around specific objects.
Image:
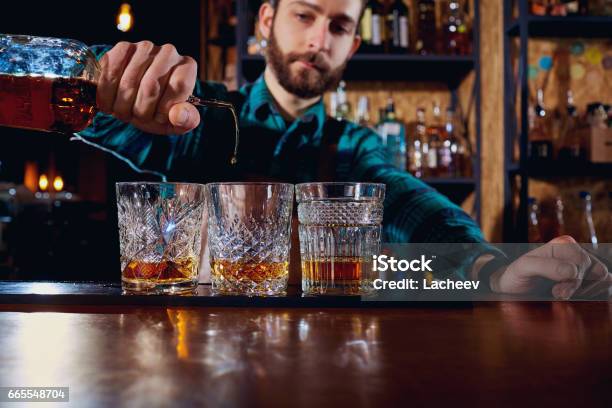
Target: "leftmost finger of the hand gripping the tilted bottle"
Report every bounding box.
[96,42,136,113]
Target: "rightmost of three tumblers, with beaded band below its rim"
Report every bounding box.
[296,183,385,295]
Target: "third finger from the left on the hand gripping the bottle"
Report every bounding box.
[132,44,181,124]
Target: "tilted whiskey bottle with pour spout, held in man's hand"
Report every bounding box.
[0,34,239,164]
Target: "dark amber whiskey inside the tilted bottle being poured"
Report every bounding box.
[0,74,96,133]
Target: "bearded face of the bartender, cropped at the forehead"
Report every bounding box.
[260,0,362,98]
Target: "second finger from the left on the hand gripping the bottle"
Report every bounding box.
[113,41,155,122]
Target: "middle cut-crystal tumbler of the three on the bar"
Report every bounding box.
[206,183,293,296]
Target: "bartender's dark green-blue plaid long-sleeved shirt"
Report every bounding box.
[81,46,502,278]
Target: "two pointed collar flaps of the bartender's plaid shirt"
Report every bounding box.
[249,75,326,135]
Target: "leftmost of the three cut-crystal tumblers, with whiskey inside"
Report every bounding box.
[116,183,205,294]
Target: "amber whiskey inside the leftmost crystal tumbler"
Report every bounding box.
[121,258,198,285]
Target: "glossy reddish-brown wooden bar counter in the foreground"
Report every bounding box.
[0,282,612,408]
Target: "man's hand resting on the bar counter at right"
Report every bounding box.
[490,236,612,299]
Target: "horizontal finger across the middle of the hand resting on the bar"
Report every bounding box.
[510,255,580,282]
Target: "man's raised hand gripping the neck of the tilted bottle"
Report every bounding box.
[97,41,200,135]
